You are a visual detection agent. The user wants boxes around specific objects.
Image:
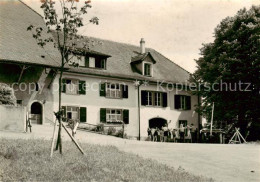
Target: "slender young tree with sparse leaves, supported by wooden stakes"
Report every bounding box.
[27,0,98,156]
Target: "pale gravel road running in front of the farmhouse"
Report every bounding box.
[0,125,260,182]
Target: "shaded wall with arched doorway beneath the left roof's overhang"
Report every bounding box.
[0,64,54,124]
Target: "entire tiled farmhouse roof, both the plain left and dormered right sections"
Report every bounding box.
[0,0,190,83]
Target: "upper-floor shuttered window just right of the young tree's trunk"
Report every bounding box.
[62,79,86,95]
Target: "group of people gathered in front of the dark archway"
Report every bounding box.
[147,124,197,143]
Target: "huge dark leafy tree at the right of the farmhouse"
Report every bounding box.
[190,6,260,139]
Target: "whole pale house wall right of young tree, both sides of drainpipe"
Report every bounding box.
[52,73,198,139]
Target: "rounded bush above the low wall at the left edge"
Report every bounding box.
[0,83,16,105]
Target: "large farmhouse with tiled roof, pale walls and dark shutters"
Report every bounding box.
[0,1,200,139]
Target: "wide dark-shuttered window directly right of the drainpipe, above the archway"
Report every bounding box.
[141,90,168,107]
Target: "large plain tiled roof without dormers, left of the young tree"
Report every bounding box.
[0,0,59,67]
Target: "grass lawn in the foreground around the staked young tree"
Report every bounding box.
[0,139,213,182]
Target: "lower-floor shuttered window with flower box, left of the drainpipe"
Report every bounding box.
[100,108,129,124]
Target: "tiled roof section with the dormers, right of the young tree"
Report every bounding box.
[53,32,190,83]
